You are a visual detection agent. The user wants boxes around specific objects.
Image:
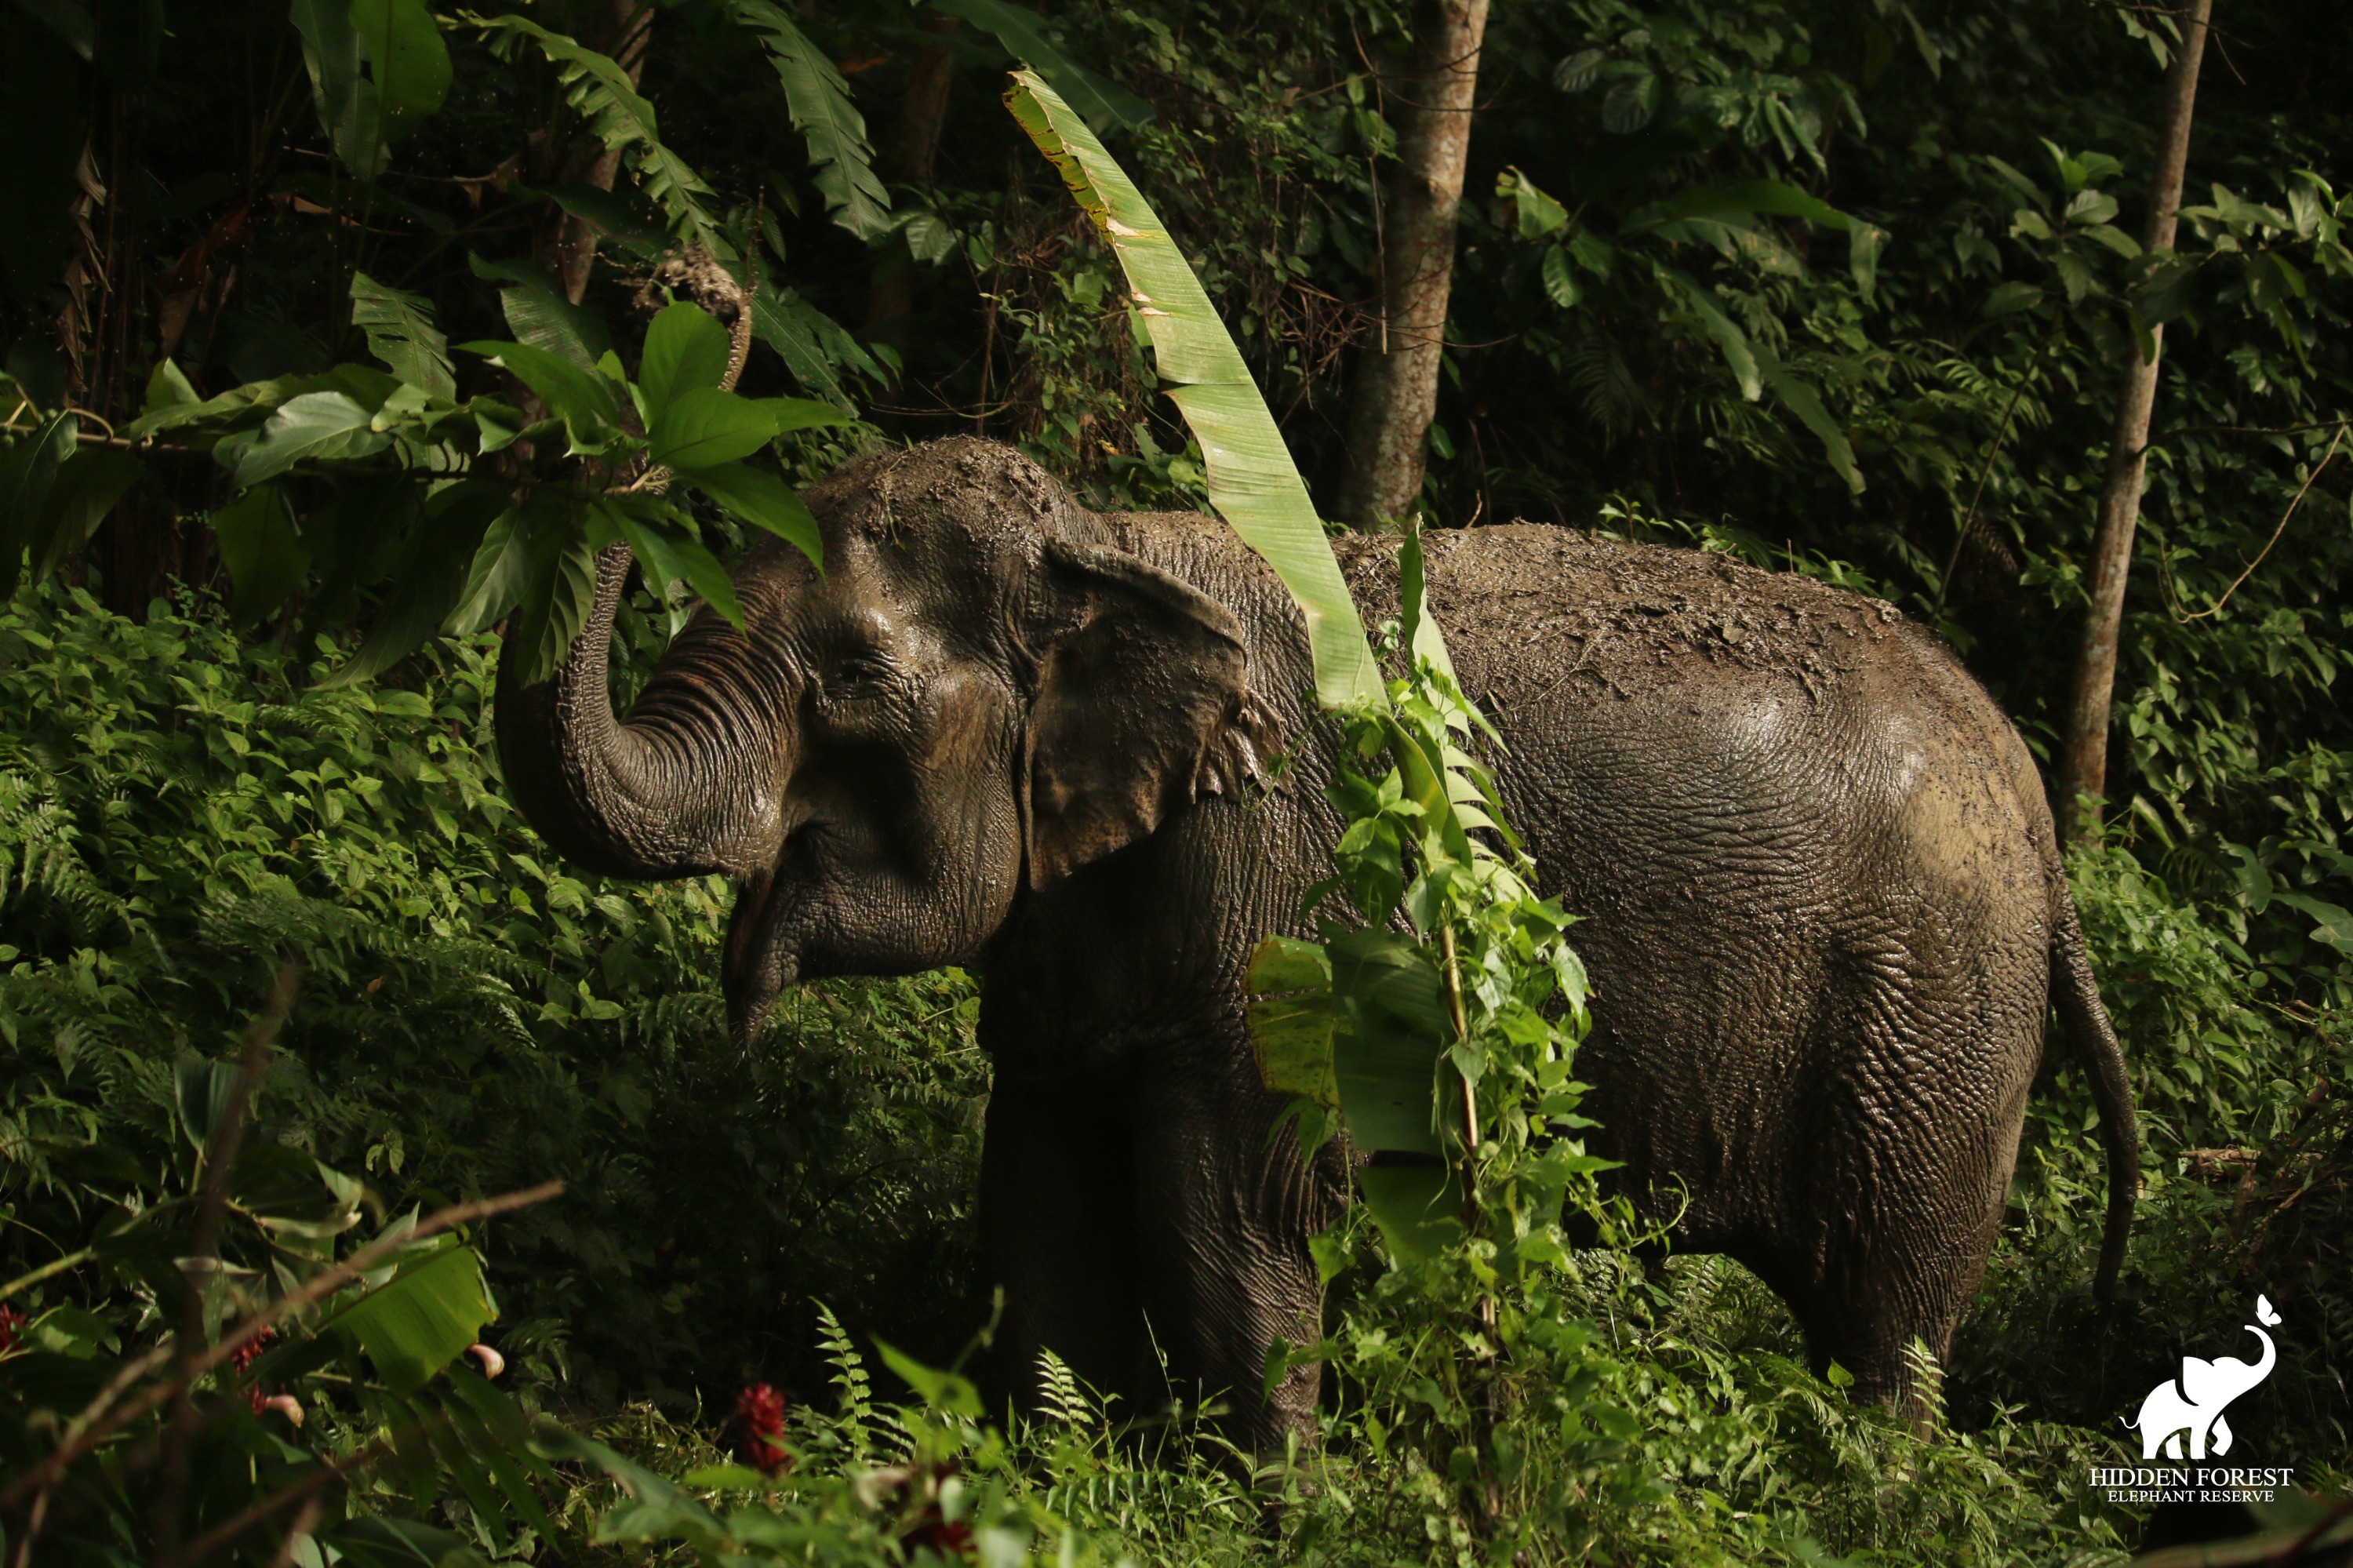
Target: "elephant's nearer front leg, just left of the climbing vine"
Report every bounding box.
[1129,1046,1346,1450]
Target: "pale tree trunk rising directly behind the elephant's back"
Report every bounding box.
[1339,0,1487,522]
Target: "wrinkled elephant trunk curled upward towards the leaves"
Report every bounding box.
[496,544,781,881]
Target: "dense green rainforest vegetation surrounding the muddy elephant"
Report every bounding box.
[0,0,2353,1563]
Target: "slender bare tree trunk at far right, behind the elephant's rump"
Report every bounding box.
[2054,0,2214,839]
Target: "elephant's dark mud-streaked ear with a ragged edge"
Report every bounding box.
[1021,539,1245,888]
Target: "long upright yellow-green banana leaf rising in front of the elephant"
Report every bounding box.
[1005,71,1388,708]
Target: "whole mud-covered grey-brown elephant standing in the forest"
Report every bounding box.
[499,440,2137,1441]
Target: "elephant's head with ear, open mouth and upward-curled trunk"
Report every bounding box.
[496,438,1249,1039]
